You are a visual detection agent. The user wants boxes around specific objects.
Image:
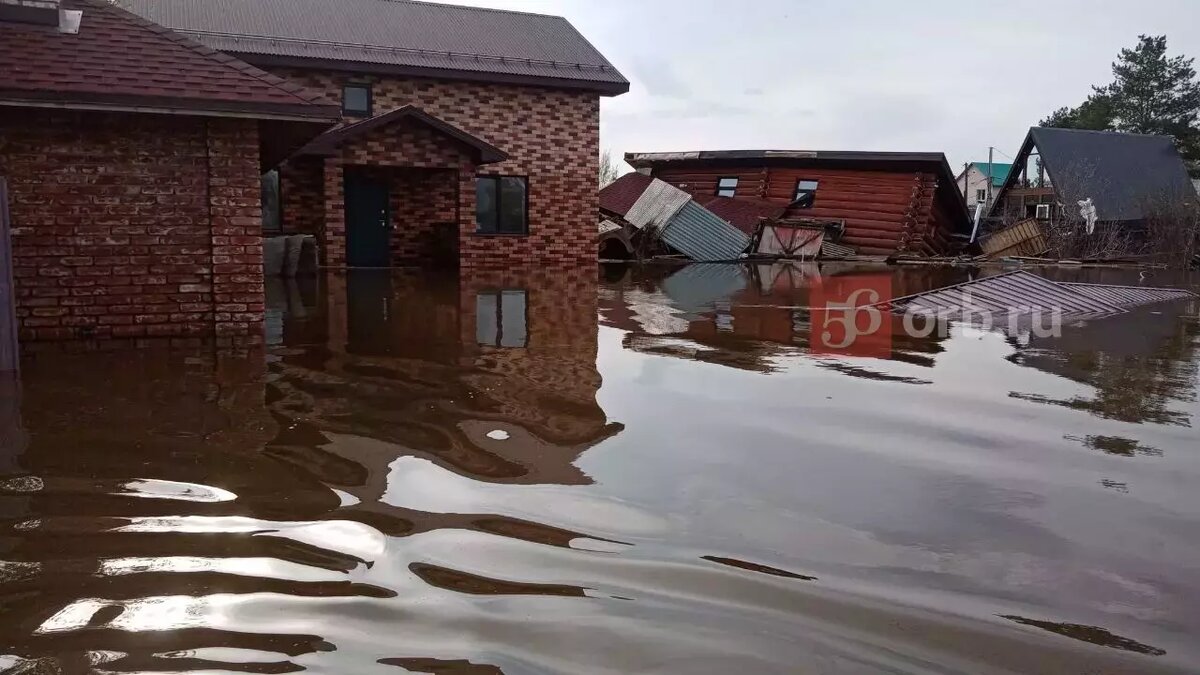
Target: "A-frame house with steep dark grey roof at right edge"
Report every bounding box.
[990,127,1196,223]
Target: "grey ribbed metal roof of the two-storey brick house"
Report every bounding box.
[122,0,629,94]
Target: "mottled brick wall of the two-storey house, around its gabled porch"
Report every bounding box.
[266,68,600,267]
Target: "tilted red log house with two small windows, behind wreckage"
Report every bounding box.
[625,150,971,255]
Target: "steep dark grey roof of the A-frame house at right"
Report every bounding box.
[1026,127,1195,221]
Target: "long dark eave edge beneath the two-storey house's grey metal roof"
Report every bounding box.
[226,49,629,96]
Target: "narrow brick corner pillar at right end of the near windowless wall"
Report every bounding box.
[205,119,264,342]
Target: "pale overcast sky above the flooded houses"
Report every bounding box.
[427,0,1200,169]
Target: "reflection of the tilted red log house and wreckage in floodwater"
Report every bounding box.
[600,262,960,376]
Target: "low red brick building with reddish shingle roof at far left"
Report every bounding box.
[0,0,338,340]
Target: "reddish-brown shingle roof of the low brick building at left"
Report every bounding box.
[0,0,340,121]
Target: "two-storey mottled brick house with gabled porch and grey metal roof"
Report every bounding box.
[130,0,629,267]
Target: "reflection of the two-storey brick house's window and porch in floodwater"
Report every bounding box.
[270,263,622,487]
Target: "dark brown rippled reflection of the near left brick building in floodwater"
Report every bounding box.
[0,341,361,673]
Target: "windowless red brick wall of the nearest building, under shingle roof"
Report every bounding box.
[0,110,263,340]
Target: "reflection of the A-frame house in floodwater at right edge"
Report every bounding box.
[1010,300,1200,426]
